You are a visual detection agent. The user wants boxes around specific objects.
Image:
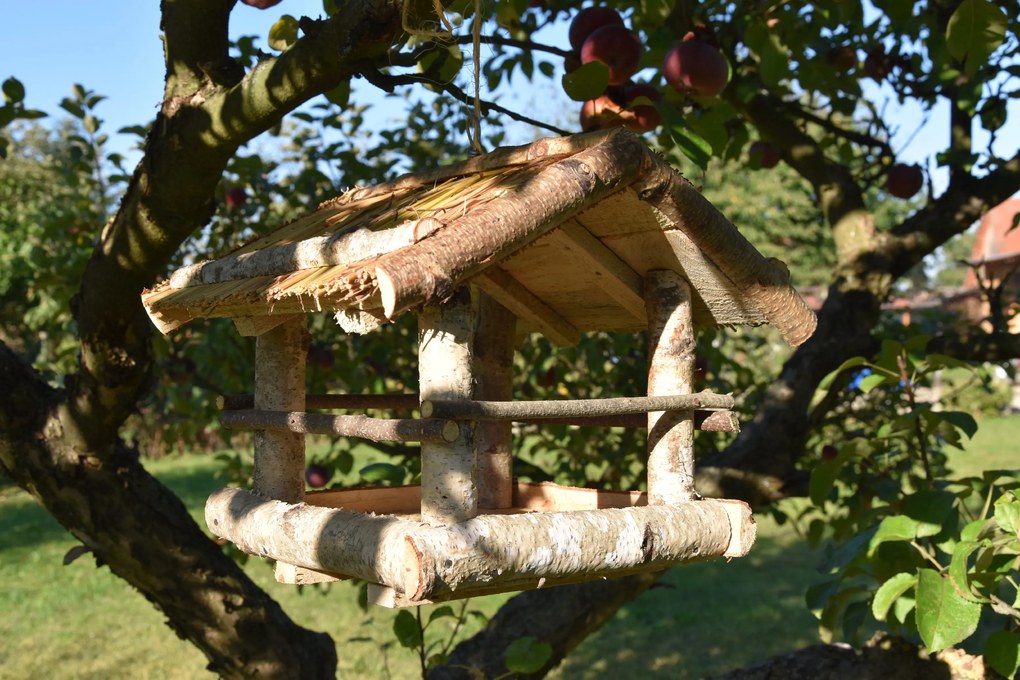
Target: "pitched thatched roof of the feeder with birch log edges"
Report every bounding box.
[143,129,815,345]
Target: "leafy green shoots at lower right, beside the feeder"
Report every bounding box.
[793,336,1020,677]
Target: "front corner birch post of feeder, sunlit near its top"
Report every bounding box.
[418,286,478,525]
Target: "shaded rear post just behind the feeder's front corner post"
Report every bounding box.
[474,291,517,509]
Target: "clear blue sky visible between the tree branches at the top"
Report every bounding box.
[0,0,1020,196]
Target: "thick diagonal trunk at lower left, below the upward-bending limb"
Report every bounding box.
[0,344,337,678]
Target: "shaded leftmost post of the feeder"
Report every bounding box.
[252,315,308,503]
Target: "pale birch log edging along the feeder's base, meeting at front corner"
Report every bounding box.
[205,488,756,605]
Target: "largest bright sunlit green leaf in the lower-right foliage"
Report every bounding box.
[915,569,981,653]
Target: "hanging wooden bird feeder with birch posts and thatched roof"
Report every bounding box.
[143,129,815,607]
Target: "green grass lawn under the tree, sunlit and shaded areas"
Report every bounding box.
[0,417,1020,679]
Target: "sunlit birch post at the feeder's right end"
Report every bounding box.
[645,270,697,505]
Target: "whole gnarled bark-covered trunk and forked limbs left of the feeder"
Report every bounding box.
[0,0,402,678]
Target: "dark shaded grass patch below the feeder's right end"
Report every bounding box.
[553,527,819,679]
